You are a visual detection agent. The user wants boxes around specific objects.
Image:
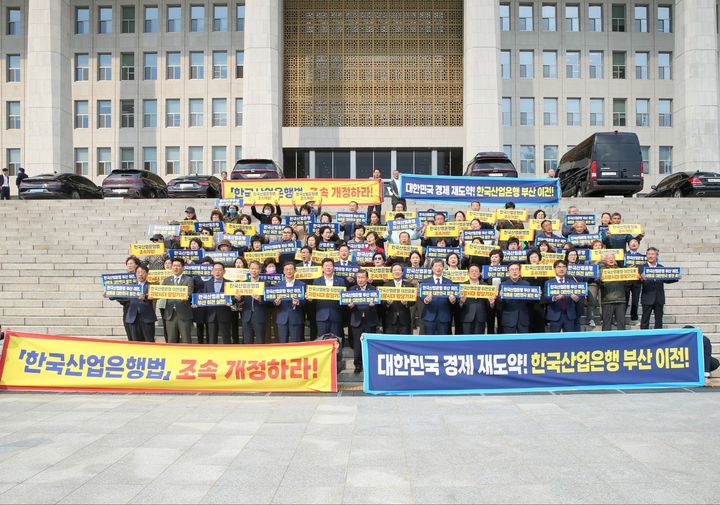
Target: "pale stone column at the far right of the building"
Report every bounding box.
[673,0,720,172]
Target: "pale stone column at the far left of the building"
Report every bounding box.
[24,0,73,175]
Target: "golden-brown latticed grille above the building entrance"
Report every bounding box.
[283,0,463,127]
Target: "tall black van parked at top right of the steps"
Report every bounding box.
[557,132,643,196]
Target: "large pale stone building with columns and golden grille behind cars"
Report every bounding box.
[0,0,720,190]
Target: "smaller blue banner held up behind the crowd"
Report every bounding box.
[400,174,560,205]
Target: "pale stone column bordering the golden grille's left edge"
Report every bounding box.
[242,0,283,164]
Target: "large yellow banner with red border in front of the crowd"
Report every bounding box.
[0,331,337,393]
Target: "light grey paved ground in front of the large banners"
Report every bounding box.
[0,390,720,503]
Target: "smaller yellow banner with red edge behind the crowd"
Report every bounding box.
[223,179,383,207]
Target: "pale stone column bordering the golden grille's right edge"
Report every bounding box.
[463,0,502,160]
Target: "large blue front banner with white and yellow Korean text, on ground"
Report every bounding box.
[362,328,704,394]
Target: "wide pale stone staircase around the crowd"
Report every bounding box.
[0,198,720,380]
